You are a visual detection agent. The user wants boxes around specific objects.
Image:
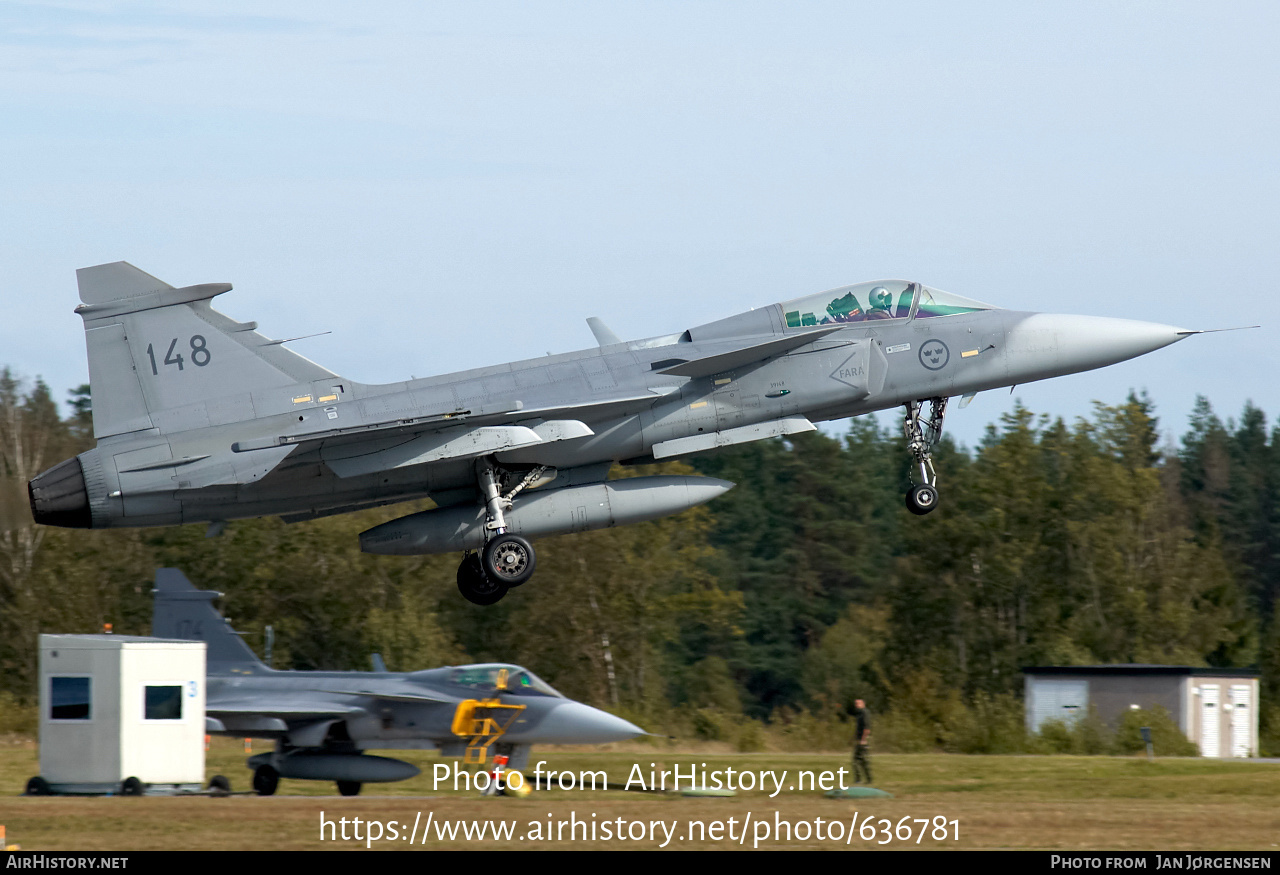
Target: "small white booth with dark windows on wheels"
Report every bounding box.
[36,635,205,796]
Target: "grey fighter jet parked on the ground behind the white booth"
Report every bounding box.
[151,568,646,796]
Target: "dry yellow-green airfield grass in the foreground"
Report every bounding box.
[0,739,1280,851]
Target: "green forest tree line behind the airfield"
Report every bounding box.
[0,370,1280,752]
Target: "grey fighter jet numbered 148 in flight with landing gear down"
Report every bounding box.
[29,261,1199,604]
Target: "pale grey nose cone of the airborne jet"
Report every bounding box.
[1005,313,1196,382]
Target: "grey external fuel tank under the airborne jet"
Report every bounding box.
[360,476,733,556]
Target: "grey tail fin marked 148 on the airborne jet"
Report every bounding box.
[76,261,335,438]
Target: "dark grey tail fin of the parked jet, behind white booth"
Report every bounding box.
[151,568,266,674]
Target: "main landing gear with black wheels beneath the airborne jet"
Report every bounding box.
[458,459,545,605]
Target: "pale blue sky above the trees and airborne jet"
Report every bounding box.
[0,0,1280,444]
